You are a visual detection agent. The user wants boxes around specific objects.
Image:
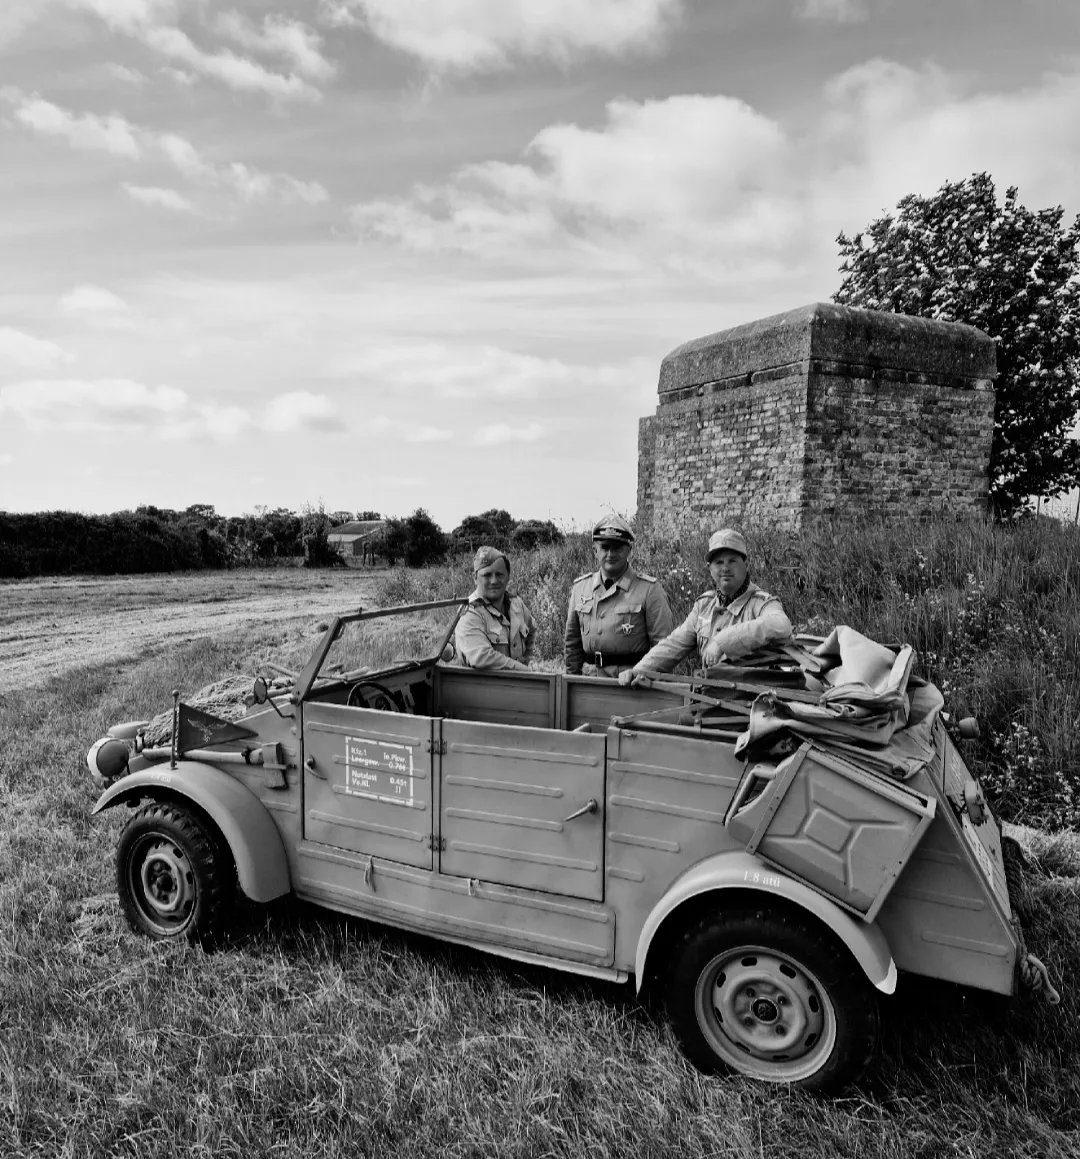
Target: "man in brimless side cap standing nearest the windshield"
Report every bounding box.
[454,547,537,672]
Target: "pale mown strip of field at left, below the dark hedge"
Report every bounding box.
[0,568,379,692]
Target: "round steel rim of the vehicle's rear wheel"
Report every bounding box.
[694,946,837,1083]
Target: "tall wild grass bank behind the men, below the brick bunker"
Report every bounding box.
[382,518,1080,829]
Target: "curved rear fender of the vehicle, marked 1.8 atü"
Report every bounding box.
[635,851,896,994]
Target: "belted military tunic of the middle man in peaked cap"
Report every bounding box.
[564,568,672,677]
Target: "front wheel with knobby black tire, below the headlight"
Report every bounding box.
[116,801,234,947]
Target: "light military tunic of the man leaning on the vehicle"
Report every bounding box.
[635,583,791,672]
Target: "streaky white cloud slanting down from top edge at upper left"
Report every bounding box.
[66,0,320,99]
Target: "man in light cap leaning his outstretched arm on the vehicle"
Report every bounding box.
[619,527,791,684]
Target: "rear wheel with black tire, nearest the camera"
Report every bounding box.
[665,909,881,1091]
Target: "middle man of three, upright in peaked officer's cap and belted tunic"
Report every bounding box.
[565,515,672,679]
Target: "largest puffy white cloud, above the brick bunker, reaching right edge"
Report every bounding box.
[351,60,1080,292]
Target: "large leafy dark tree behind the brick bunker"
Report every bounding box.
[833,173,1080,516]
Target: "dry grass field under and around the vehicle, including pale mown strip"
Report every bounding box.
[0,544,1080,1159]
